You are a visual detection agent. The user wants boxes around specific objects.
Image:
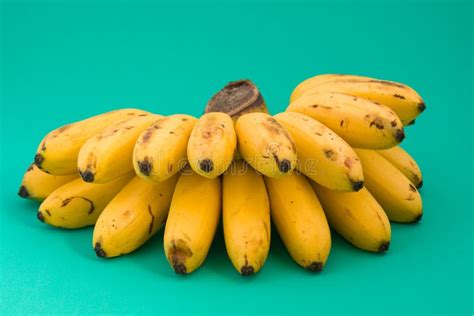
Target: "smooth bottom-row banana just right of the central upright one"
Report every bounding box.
[265,173,331,272]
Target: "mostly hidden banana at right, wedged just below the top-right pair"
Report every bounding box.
[377,146,423,189]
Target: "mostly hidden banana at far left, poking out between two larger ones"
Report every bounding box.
[18,163,79,201]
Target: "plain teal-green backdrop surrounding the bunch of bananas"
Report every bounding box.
[0,0,474,315]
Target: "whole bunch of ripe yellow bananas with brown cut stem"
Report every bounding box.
[19,75,425,275]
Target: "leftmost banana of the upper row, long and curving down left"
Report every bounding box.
[35,109,147,176]
